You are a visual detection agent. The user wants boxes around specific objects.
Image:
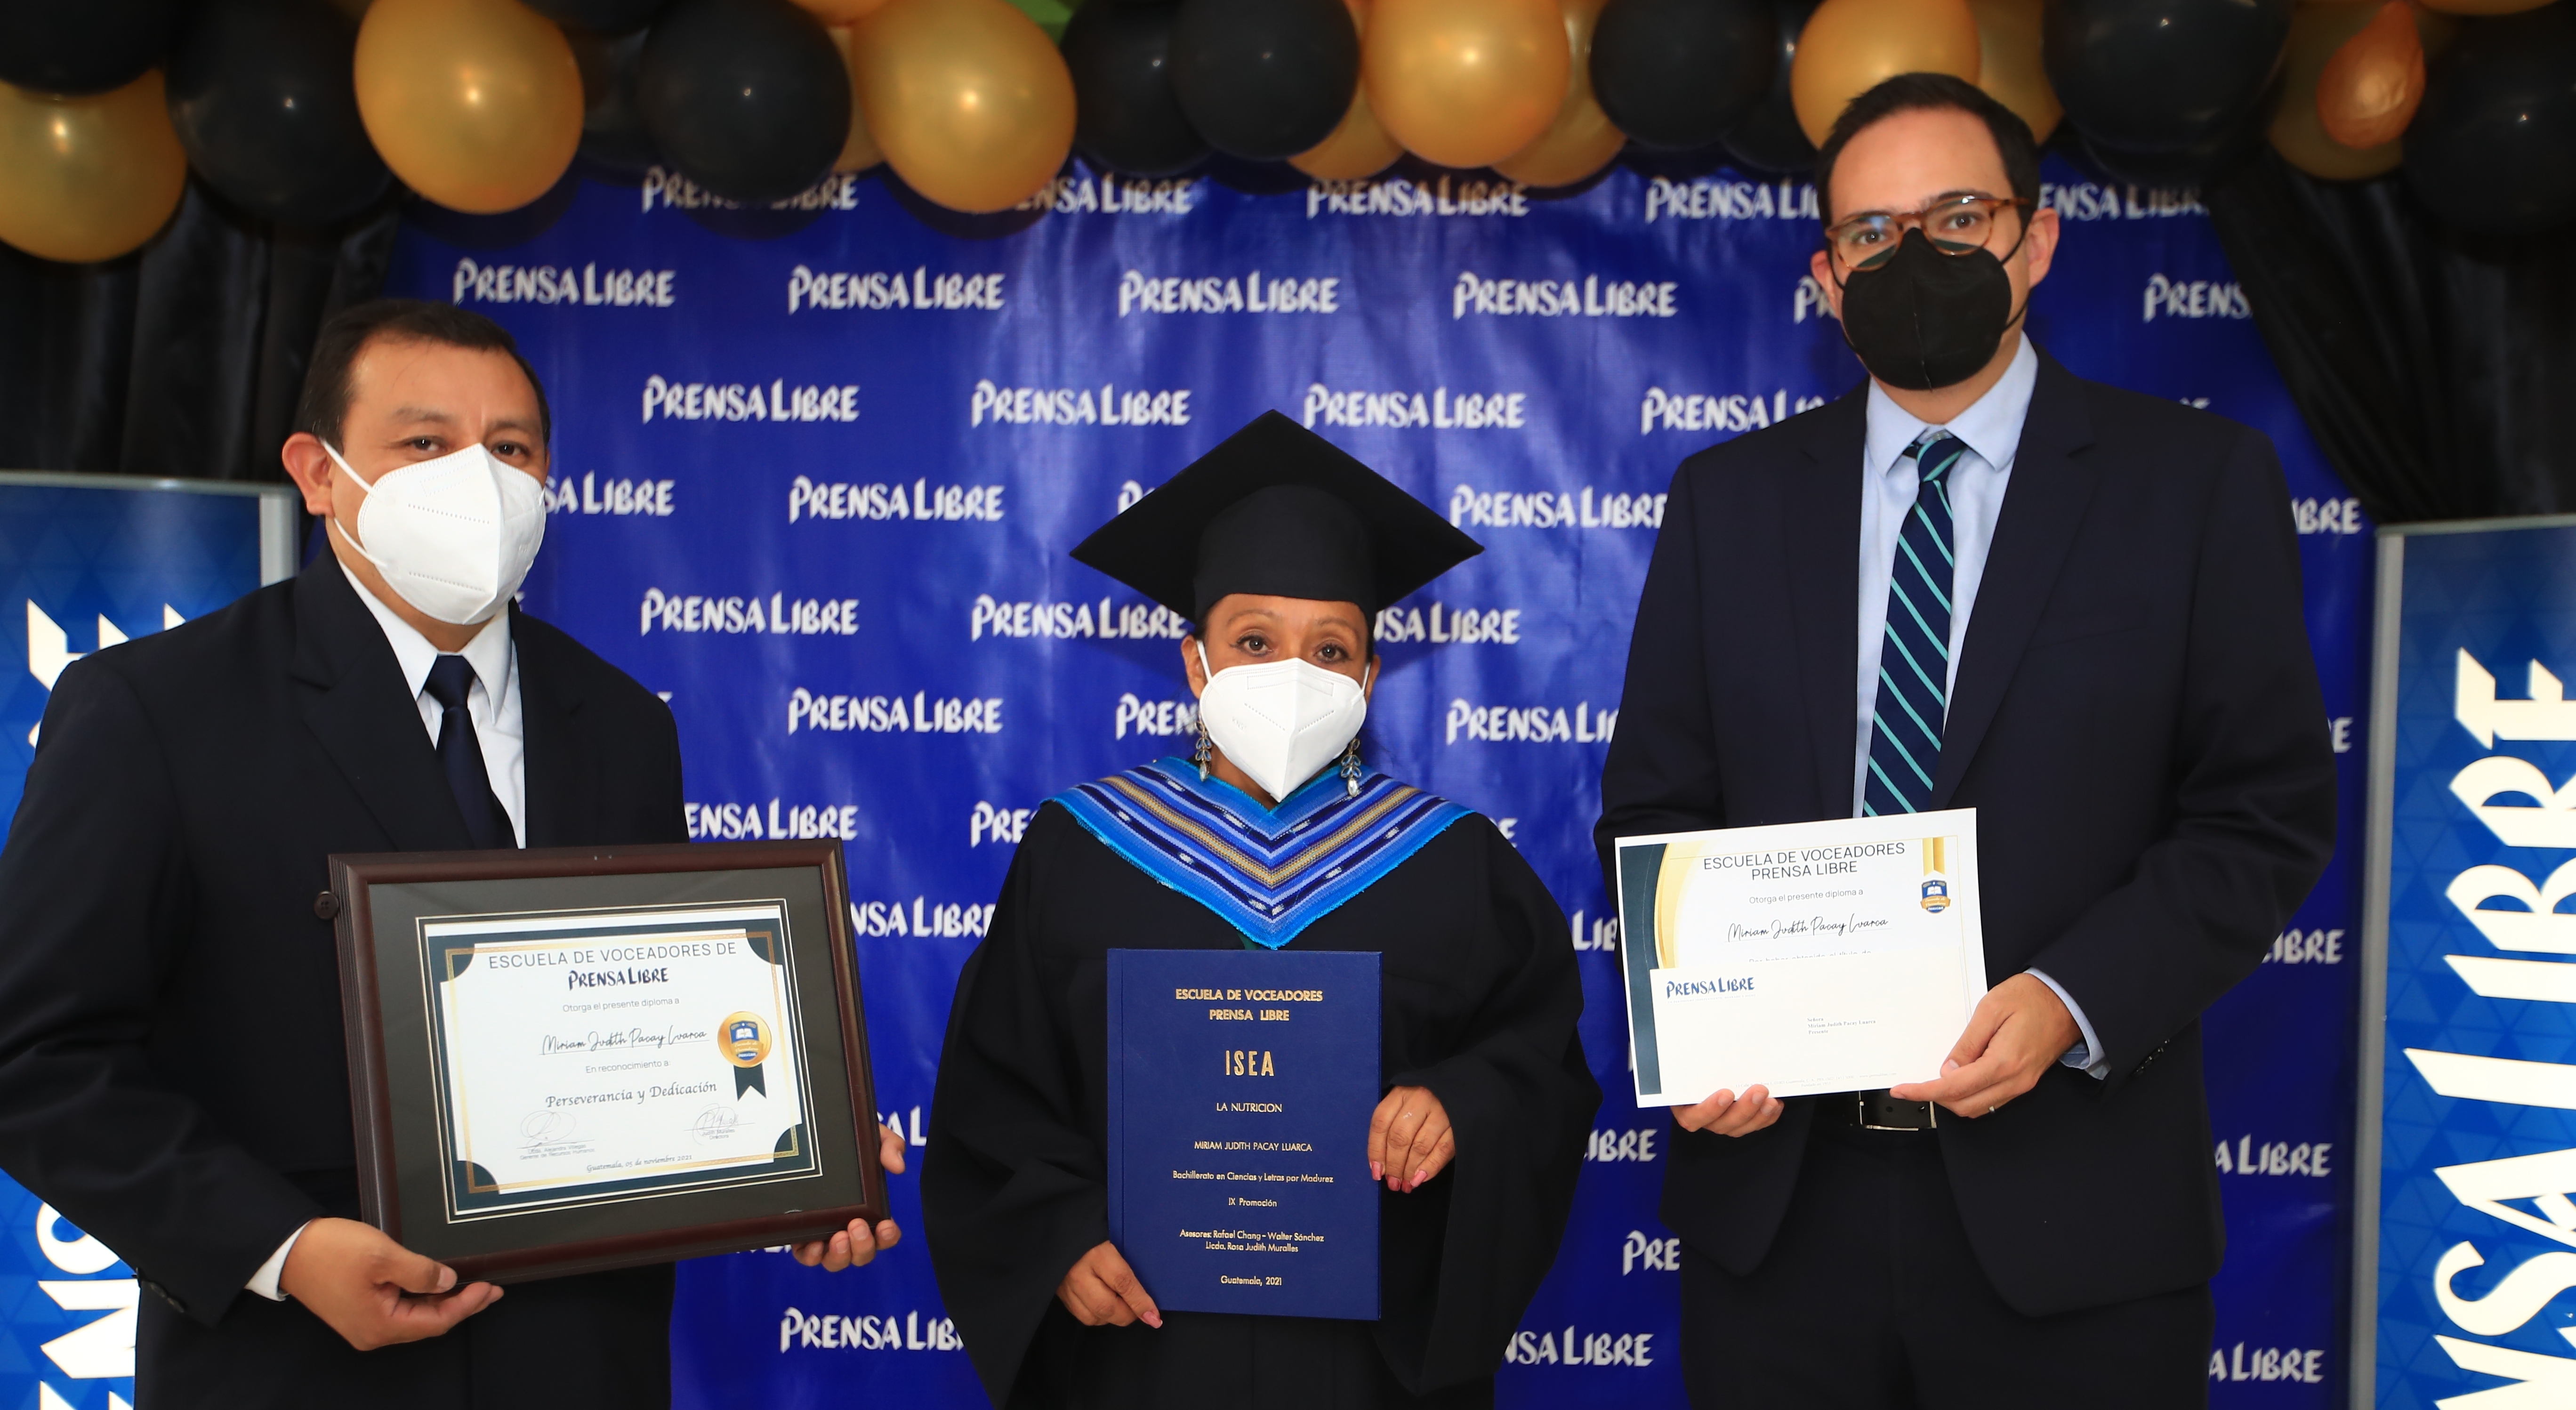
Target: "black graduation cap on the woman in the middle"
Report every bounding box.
[1074,412,1484,621]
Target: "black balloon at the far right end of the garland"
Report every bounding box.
[2406,5,2576,234]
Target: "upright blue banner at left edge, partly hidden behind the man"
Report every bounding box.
[0,474,296,1410]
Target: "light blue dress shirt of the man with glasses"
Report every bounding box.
[1852,338,2110,1078]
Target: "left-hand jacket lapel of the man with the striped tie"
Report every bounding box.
[1780,392,1868,817]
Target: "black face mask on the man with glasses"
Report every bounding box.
[1842,229,2022,392]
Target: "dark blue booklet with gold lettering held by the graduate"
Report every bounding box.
[1108,949,1378,1322]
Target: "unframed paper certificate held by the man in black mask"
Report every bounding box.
[1618,809,1986,1106]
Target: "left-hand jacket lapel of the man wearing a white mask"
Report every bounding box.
[291,552,474,851]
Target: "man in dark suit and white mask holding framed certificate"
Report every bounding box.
[0,299,902,1410]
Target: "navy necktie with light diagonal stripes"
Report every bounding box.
[1860,430,1968,817]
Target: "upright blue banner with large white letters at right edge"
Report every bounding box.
[2354,518,2576,1410]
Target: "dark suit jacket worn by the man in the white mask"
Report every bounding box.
[0,554,688,1330]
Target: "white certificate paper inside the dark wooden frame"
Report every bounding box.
[417,902,817,1222]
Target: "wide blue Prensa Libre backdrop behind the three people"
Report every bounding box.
[407,149,2370,1410]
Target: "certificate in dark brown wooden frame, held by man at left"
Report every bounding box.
[330,840,886,1284]
